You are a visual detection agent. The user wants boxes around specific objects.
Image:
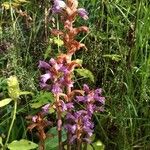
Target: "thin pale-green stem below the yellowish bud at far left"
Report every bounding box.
[4,100,17,147]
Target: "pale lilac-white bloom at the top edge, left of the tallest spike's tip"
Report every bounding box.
[52,0,66,13]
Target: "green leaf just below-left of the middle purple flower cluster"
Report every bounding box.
[30,92,54,109]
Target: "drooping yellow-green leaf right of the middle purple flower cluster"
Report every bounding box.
[75,69,94,82]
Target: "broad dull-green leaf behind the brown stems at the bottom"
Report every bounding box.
[45,127,67,150]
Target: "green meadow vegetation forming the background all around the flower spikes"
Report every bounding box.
[0,0,150,150]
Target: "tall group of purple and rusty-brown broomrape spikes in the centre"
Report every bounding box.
[37,0,105,150]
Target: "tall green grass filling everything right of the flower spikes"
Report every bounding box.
[83,0,150,150]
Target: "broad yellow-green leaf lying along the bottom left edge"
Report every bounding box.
[8,139,38,150]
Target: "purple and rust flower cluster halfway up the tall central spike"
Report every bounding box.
[39,56,79,94]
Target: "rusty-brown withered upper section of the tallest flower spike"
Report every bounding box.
[51,0,89,57]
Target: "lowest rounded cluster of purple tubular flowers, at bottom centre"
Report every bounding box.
[65,110,94,143]
